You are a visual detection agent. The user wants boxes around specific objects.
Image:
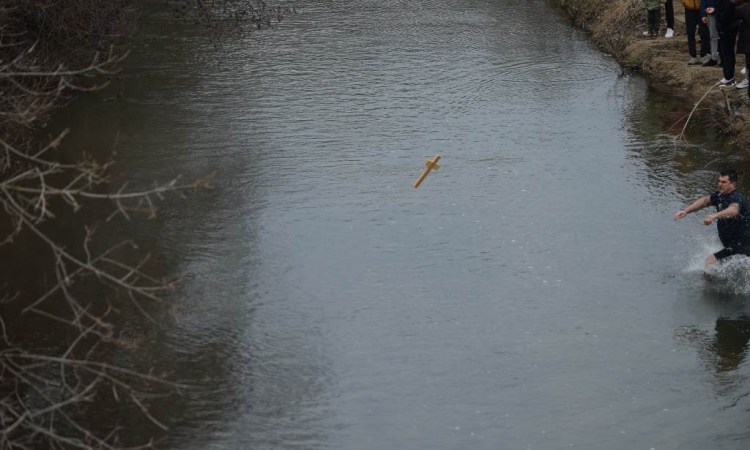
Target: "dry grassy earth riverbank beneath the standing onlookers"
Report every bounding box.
[553,0,750,146]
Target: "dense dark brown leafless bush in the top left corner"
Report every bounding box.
[0,0,136,134]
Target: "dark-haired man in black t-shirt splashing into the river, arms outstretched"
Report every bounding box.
[674,170,750,266]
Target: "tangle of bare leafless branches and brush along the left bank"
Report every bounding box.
[0,0,225,450]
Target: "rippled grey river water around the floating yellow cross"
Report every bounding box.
[16,0,750,450]
